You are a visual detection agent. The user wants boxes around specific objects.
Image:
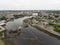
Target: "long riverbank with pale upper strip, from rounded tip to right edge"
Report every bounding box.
[24,19,60,39]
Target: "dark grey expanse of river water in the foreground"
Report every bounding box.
[7,26,60,45]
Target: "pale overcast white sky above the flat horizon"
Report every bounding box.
[0,0,60,10]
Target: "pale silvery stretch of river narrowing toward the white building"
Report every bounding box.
[6,17,30,30]
